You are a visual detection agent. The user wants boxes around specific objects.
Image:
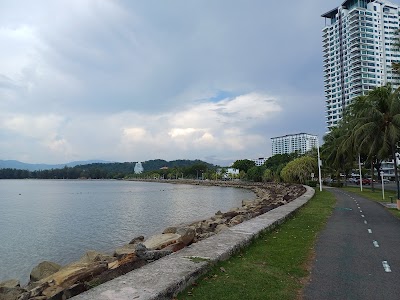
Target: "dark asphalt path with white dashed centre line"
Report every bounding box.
[304,189,400,300]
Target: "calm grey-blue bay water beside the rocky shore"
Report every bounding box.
[0,180,255,283]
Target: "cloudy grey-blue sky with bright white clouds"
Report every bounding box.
[0,0,348,165]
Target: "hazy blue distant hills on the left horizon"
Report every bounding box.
[0,160,109,171]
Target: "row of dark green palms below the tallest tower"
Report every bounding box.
[321,84,400,199]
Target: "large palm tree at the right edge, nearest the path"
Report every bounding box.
[350,84,400,199]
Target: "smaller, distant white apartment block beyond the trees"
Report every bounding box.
[271,133,318,155]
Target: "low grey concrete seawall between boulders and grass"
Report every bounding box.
[72,187,315,300]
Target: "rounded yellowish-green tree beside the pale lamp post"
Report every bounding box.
[281,156,318,184]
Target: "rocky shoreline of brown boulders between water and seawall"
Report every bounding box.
[0,180,306,300]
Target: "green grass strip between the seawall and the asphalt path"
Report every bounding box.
[177,191,335,300]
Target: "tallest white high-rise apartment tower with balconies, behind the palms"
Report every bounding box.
[322,0,400,130]
